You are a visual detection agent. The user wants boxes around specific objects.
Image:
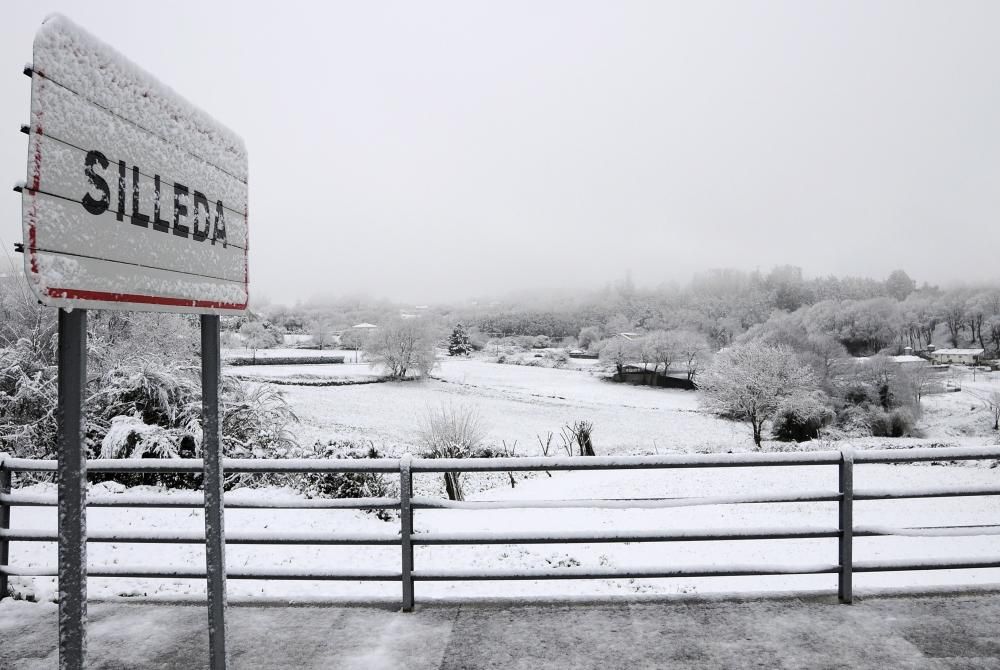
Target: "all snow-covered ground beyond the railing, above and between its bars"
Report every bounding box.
[5,359,1000,599]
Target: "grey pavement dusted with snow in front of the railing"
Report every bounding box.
[0,593,1000,670]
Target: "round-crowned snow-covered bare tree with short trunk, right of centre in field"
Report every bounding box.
[699,342,816,449]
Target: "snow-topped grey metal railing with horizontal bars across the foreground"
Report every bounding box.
[0,448,1000,611]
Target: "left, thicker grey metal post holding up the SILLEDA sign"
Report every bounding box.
[58,309,87,670]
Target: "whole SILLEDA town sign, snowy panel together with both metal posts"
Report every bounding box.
[19,15,250,670]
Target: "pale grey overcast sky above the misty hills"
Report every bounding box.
[0,0,1000,302]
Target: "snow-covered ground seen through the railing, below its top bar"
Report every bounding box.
[11,465,1000,600]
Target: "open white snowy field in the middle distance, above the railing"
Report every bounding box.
[282,360,749,456]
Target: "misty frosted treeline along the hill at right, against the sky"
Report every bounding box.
[460,266,1000,356]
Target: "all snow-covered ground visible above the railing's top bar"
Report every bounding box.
[268,358,1000,455]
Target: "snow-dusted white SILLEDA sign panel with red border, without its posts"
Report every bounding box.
[22,16,249,314]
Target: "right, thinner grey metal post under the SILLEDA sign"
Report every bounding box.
[201,314,227,670]
